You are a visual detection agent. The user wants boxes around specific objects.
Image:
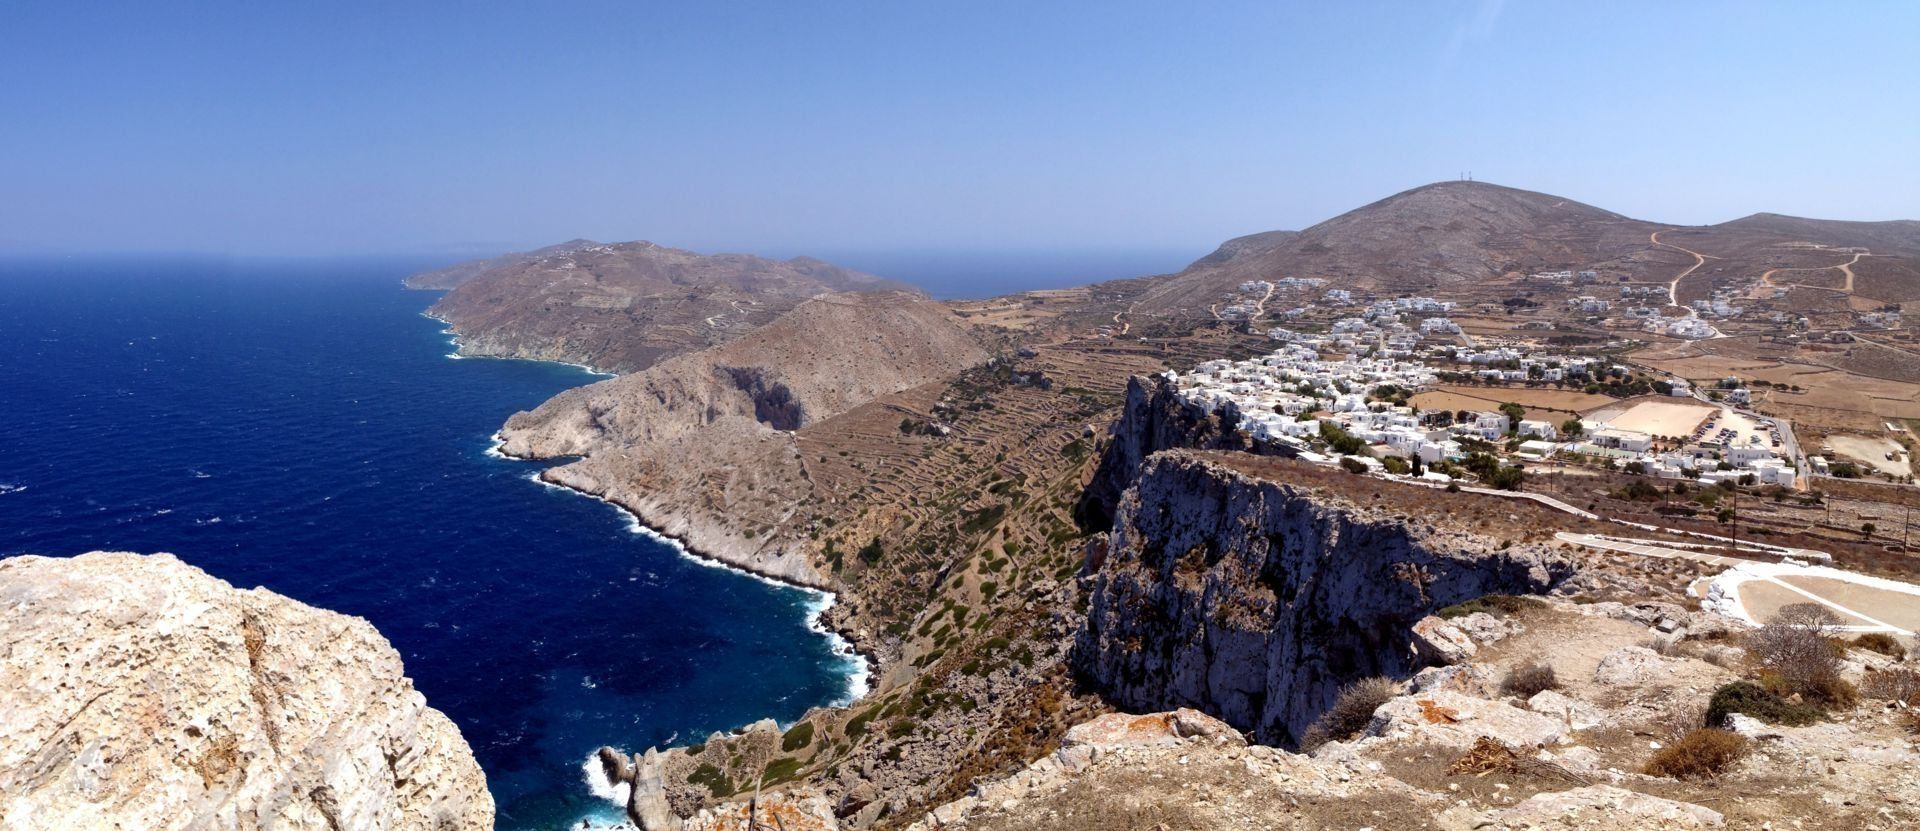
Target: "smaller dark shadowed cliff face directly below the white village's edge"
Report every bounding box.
[1079,374,1252,528]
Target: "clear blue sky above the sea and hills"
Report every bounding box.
[0,0,1920,255]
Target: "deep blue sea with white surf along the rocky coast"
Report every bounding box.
[0,259,858,829]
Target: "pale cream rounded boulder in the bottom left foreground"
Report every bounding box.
[0,553,493,831]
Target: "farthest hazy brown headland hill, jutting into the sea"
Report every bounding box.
[428,242,908,372]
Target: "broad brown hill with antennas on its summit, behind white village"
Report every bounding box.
[1135,182,1920,321]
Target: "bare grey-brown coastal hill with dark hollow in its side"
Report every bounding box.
[501,292,987,583]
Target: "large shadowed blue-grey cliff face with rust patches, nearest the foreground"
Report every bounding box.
[1073,451,1572,745]
